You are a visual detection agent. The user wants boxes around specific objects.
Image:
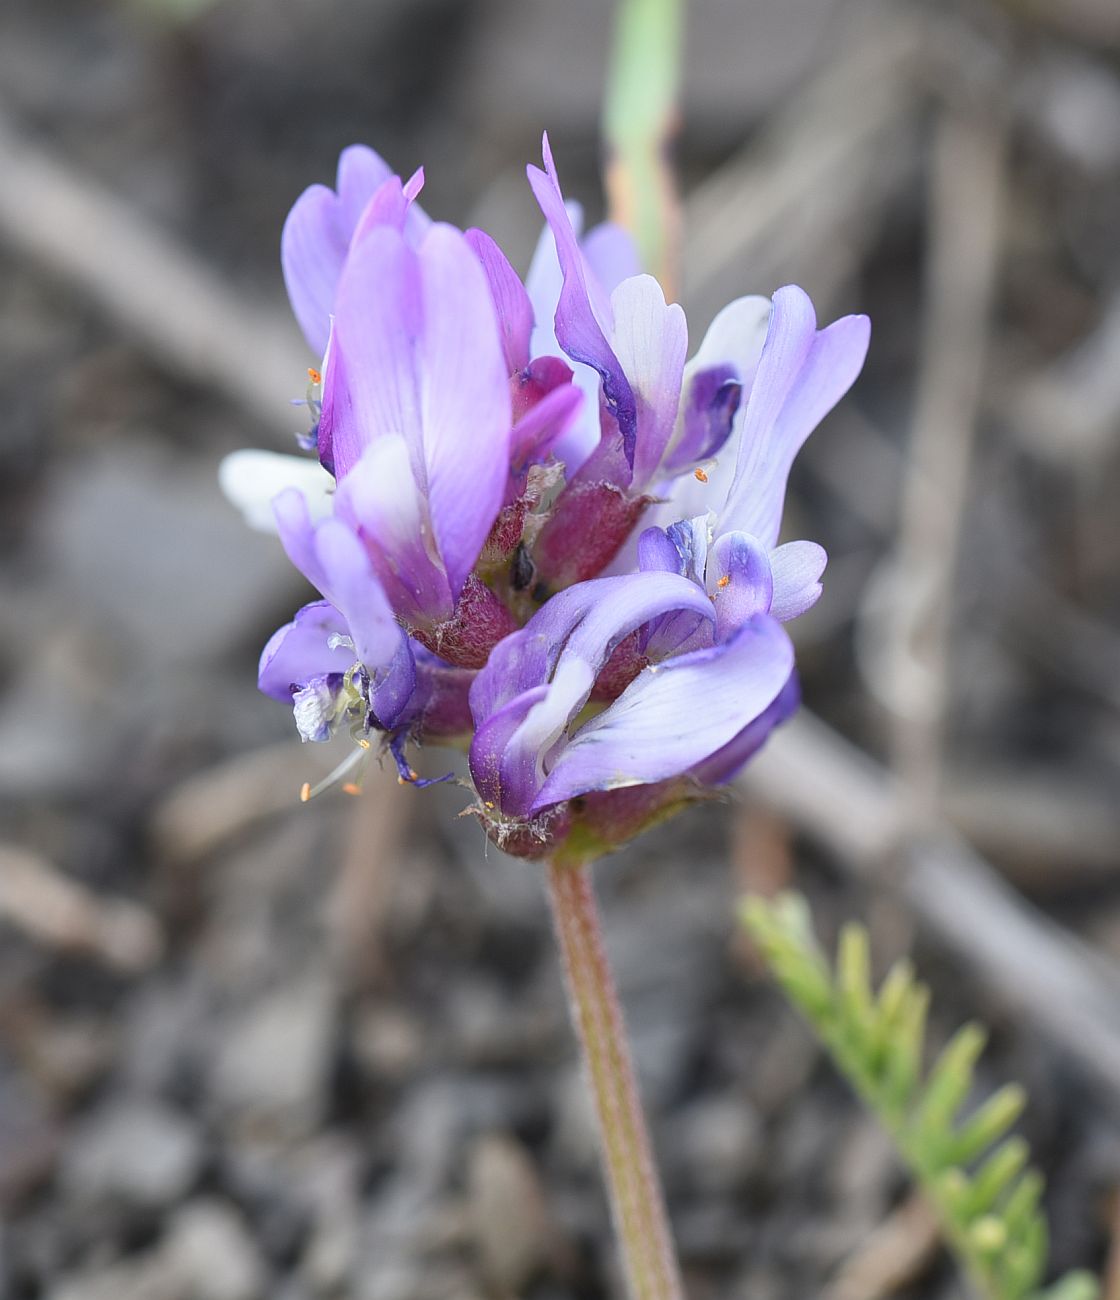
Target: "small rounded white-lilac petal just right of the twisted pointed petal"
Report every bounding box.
[611,276,689,491]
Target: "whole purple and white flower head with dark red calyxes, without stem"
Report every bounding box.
[222,139,869,855]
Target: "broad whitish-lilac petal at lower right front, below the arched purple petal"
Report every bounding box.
[531,616,794,813]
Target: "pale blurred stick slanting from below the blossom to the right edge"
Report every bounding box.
[741,710,1120,1110]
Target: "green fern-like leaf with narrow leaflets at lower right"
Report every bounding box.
[742,894,1099,1300]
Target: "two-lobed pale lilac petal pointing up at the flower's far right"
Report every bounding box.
[720,286,871,546]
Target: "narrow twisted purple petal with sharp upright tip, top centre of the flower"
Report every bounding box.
[528,137,635,464]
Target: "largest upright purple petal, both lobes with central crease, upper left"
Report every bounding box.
[321,225,512,599]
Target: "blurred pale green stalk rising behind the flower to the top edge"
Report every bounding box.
[603,0,683,300]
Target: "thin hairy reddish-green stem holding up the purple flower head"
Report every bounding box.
[548,862,683,1300]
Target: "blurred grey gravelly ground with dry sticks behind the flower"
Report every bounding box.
[0,0,1120,1300]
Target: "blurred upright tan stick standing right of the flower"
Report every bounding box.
[880,108,1007,823]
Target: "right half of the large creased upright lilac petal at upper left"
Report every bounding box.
[417,225,512,598]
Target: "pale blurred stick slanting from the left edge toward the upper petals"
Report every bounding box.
[0,112,311,428]
